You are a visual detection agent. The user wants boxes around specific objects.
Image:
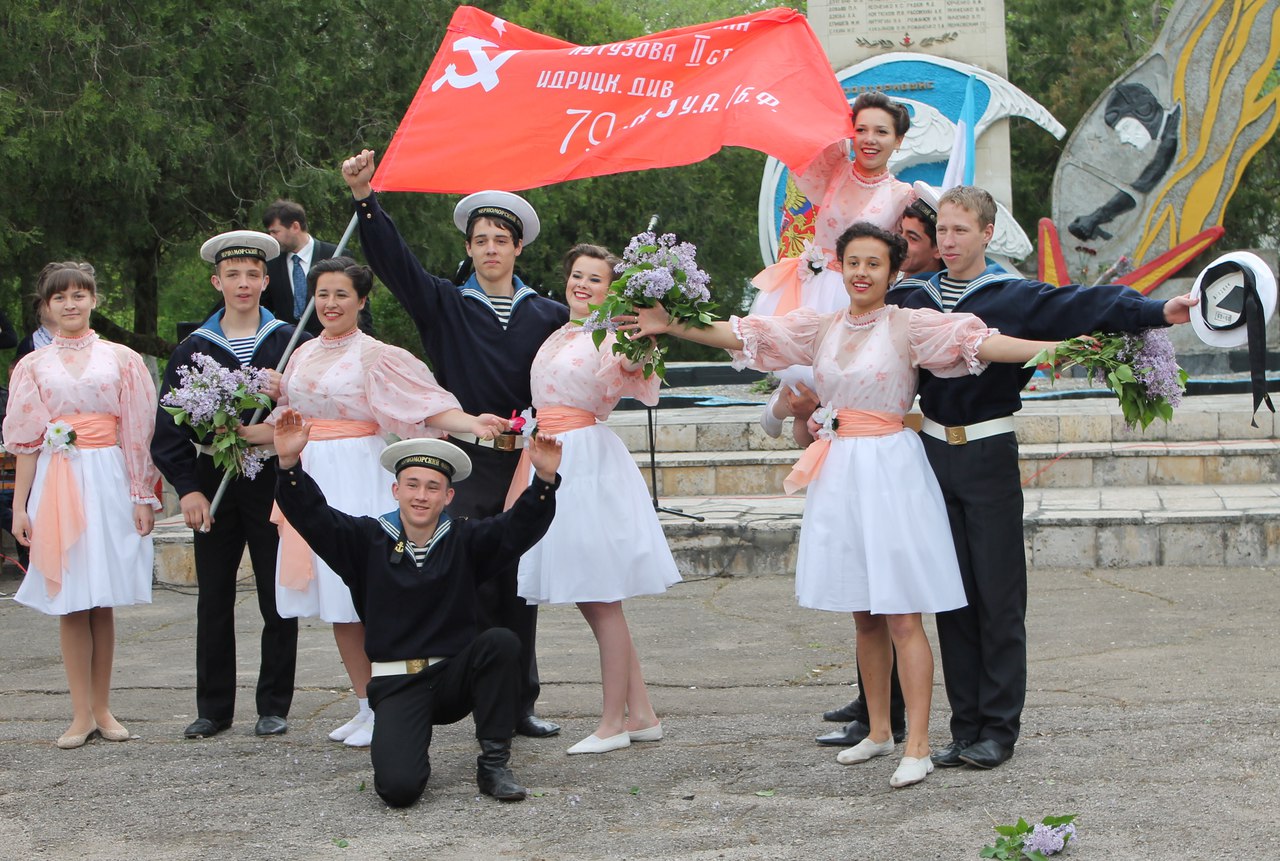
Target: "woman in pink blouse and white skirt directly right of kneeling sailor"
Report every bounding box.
[508,244,680,754]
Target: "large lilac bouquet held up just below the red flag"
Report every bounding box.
[581,229,716,377]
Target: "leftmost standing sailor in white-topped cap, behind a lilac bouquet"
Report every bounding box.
[151,230,298,738]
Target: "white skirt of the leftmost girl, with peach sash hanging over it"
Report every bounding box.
[14,446,155,615]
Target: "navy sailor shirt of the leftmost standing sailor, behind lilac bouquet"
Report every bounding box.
[151,308,311,498]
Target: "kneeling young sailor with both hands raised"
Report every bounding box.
[275,409,561,807]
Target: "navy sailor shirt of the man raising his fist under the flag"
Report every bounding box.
[355,192,568,417]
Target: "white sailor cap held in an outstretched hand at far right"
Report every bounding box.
[1192,251,1276,348]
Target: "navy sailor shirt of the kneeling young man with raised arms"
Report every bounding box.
[275,466,561,661]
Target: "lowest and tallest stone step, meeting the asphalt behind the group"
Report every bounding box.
[155,485,1280,586]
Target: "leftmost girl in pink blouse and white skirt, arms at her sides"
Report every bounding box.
[4,262,160,748]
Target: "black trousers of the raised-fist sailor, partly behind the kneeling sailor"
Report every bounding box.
[449,439,541,716]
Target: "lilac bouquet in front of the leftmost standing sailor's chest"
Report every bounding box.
[161,353,271,478]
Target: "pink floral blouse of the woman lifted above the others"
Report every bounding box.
[795,143,915,255]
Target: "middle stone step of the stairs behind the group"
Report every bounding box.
[635,440,1280,496]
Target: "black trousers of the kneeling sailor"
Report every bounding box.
[369,628,520,807]
